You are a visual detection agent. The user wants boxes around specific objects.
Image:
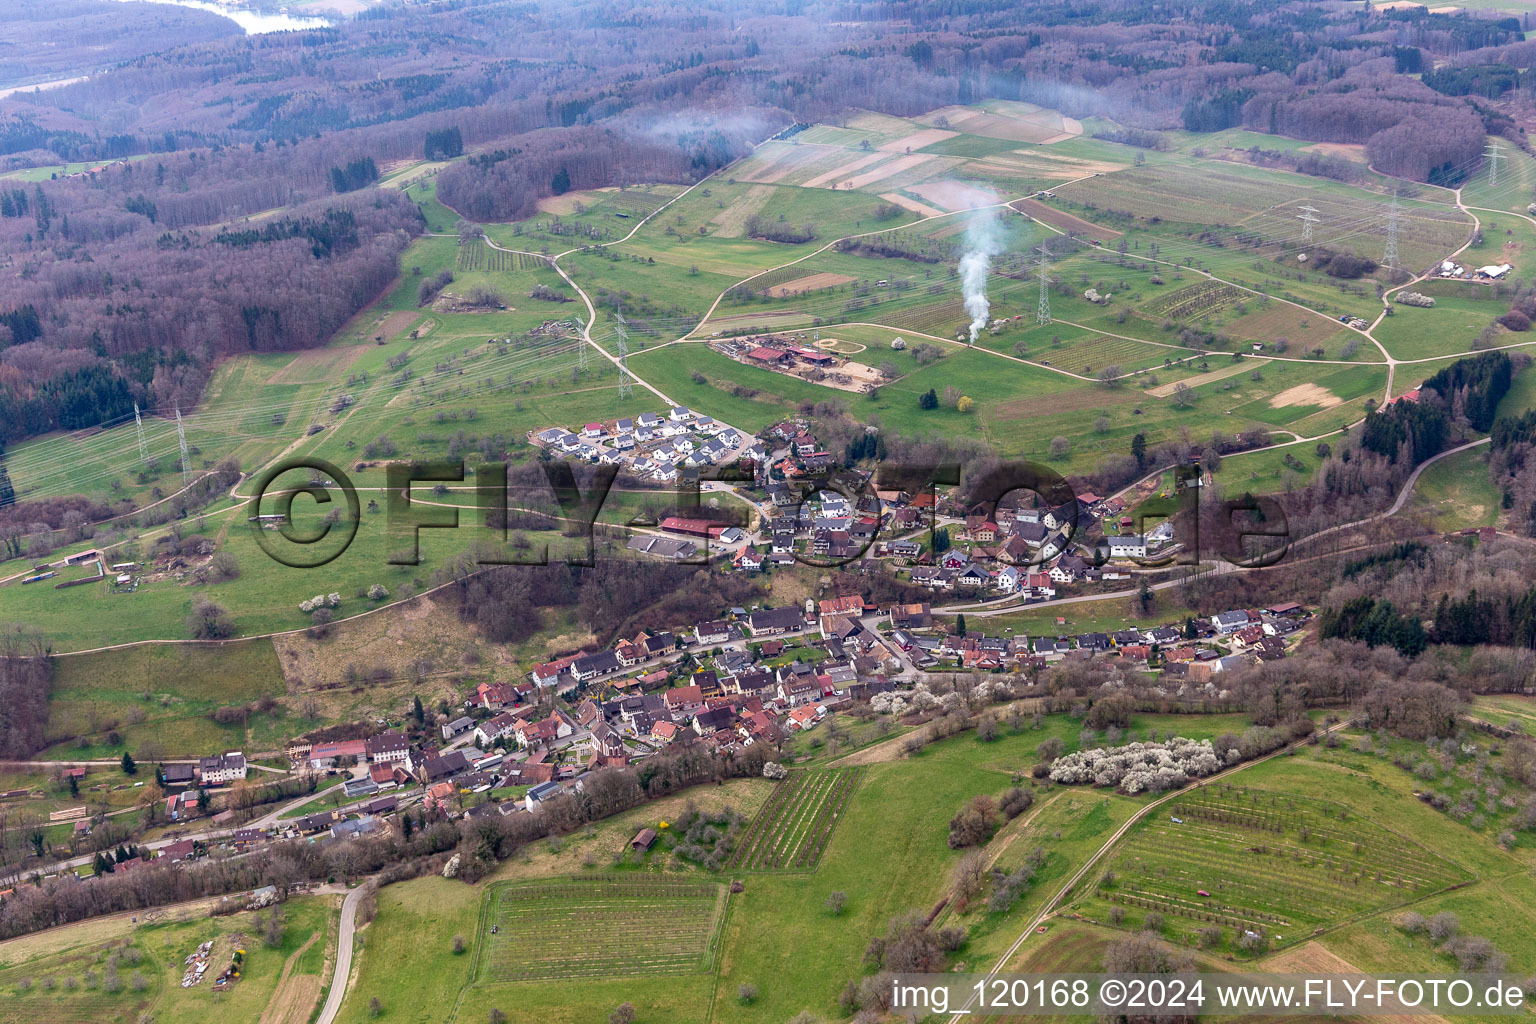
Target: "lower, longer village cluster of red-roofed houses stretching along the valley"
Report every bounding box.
[0,568,1309,902]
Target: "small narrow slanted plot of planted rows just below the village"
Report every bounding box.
[728,768,862,870]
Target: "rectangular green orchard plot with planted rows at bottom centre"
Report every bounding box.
[476,875,727,984]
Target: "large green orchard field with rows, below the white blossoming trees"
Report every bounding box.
[1081,783,1473,943]
